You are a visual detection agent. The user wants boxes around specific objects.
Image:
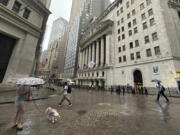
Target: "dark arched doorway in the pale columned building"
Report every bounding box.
[134,70,143,92]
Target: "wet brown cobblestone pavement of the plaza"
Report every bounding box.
[0,90,180,135]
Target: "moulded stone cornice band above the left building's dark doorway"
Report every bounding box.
[0,4,42,38]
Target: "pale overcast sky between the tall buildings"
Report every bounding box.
[43,0,114,50]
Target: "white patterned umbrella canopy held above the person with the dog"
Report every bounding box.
[16,77,45,85]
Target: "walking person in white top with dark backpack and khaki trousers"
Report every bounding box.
[59,82,72,106]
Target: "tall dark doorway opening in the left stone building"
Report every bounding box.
[0,33,16,83]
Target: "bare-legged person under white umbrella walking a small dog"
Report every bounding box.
[13,85,30,130]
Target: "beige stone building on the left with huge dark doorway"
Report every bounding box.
[0,0,50,83]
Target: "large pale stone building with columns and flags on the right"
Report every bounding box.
[77,0,180,94]
